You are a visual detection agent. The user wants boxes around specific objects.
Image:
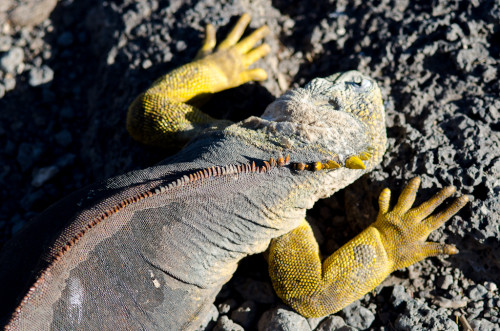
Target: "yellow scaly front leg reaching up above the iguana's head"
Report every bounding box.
[127,14,269,145]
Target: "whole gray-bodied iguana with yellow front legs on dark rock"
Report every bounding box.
[0,14,468,330]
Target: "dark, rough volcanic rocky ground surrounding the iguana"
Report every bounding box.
[0,0,500,330]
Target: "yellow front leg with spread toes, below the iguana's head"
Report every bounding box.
[268,178,468,317]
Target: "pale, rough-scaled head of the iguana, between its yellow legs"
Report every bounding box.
[250,71,386,169]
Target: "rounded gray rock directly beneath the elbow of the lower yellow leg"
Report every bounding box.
[257,306,311,331]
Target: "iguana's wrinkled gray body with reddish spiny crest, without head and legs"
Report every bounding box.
[0,133,336,330]
